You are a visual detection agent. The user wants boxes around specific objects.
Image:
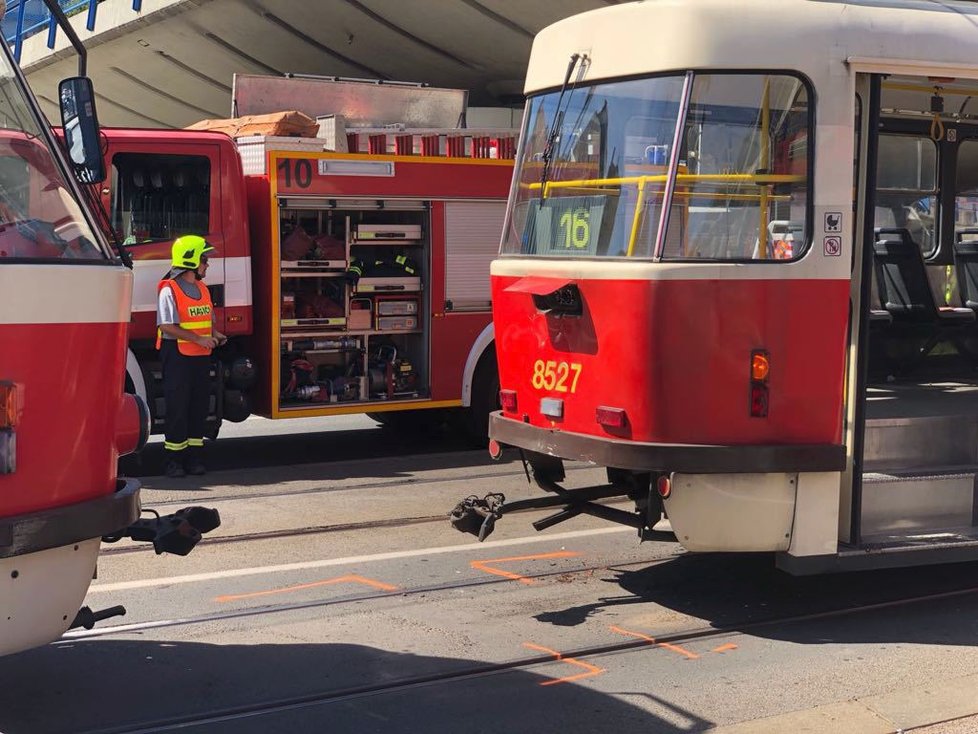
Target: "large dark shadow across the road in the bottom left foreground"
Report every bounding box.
[0,640,711,734]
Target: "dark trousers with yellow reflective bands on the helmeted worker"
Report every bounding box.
[160,339,211,463]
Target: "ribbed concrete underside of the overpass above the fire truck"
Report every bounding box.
[24,0,618,127]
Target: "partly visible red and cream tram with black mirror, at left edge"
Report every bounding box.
[0,0,220,655]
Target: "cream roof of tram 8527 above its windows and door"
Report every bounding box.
[525,0,978,94]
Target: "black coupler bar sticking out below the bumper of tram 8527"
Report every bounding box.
[449,486,645,542]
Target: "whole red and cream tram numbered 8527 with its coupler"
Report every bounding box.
[454,0,978,573]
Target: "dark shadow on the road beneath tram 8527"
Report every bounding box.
[535,553,978,646]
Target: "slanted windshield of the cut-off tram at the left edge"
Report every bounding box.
[0,44,108,266]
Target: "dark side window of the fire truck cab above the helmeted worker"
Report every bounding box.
[112,153,211,245]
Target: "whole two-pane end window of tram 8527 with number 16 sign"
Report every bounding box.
[502,73,812,261]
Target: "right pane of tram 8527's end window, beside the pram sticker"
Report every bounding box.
[663,74,811,260]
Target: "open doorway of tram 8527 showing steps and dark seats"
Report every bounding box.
[852,75,978,560]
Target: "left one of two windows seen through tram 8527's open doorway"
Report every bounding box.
[874,134,936,257]
